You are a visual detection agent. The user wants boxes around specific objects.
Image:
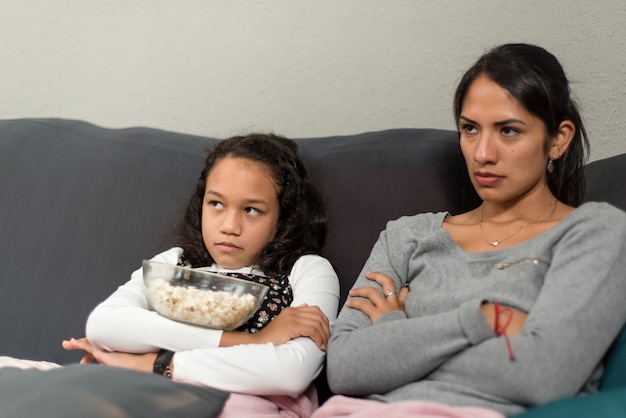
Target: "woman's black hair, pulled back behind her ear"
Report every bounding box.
[454,44,589,206]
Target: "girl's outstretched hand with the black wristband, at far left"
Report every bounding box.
[62,338,157,373]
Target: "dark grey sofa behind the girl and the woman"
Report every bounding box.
[0,119,626,417]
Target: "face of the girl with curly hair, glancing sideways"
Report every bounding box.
[202,157,279,269]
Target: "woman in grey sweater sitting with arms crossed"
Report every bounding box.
[315,44,626,417]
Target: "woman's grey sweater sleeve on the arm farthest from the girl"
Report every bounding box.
[440,204,626,405]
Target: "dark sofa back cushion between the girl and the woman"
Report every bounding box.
[298,129,479,303]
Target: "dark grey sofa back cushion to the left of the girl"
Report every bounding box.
[0,119,217,363]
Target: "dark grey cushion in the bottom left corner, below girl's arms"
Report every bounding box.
[0,365,228,418]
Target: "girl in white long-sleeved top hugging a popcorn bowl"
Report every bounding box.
[63,134,339,417]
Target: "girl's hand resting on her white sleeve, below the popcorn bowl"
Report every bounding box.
[220,304,330,351]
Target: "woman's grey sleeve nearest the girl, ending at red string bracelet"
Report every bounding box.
[327,216,493,396]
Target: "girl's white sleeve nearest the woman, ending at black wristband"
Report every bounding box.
[169,255,339,396]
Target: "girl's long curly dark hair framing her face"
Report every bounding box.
[175,133,328,274]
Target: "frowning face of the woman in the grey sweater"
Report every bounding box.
[458,75,549,206]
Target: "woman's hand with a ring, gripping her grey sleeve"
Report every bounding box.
[346,272,409,324]
